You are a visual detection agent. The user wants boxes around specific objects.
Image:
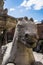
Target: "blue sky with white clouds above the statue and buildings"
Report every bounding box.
[4,0,43,21]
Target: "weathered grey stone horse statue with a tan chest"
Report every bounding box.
[1,18,37,65]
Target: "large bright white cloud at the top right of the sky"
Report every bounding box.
[20,0,43,10]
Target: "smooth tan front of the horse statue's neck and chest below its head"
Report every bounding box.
[15,43,34,65]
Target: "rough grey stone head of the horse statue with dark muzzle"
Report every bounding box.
[17,18,37,47]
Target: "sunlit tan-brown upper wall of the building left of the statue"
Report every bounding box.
[0,15,16,33]
